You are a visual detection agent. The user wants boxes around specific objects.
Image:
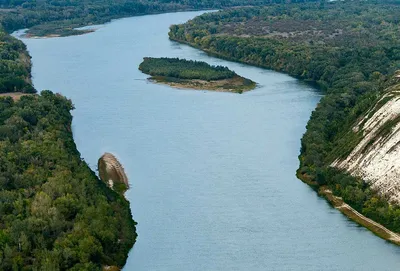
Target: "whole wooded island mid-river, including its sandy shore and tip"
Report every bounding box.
[139,57,256,93]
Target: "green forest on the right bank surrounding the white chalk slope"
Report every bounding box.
[169,1,400,232]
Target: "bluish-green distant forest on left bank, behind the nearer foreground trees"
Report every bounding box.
[0,0,313,93]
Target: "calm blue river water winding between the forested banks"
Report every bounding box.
[15,12,400,271]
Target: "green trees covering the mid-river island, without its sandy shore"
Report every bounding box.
[139,57,236,81]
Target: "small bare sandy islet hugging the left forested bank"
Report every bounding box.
[98,153,129,189]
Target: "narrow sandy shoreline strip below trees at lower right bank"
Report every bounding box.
[319,187,400,245]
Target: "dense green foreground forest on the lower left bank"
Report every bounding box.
[0,91,136,271]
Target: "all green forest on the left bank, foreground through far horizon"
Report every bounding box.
[0,0,316,270]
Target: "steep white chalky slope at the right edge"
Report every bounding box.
[331,72,400,204]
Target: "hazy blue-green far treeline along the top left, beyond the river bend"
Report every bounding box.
[0,0,313,36]
